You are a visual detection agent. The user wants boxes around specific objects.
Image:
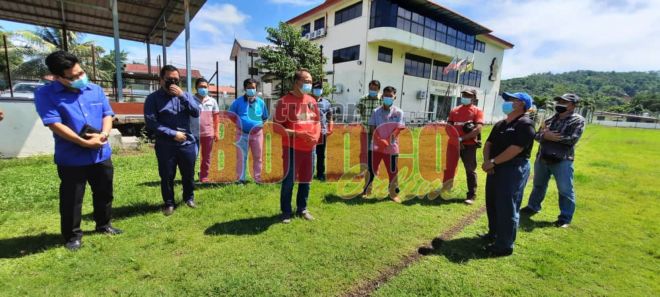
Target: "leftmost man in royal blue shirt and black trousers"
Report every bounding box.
[34,51,122,251]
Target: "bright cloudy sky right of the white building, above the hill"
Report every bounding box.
[438,0,660,78]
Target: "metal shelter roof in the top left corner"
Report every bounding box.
[0,0,206,46]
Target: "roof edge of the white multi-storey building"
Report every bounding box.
[287,0,513,48]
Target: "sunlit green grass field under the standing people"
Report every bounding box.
[0,126,660,296]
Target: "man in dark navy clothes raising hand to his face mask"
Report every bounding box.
[144,65,199,216]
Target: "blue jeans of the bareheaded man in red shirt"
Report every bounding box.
[280,148,314,217]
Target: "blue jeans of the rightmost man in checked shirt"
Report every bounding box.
[527,158,575,223]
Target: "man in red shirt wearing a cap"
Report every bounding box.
[447,90,484,205]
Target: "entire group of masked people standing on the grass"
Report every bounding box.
[35,51,584,255]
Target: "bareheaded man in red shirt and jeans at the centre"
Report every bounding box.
[273,69,321,224]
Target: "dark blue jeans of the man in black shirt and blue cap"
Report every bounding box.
[486,159,530,250]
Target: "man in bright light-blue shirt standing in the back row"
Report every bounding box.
[229,78,268,184]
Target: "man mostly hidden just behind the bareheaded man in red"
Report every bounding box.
[312,82,333,181]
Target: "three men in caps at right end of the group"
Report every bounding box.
[448,90,585,256]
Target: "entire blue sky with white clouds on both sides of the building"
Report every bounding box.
[0,0,660,85]
